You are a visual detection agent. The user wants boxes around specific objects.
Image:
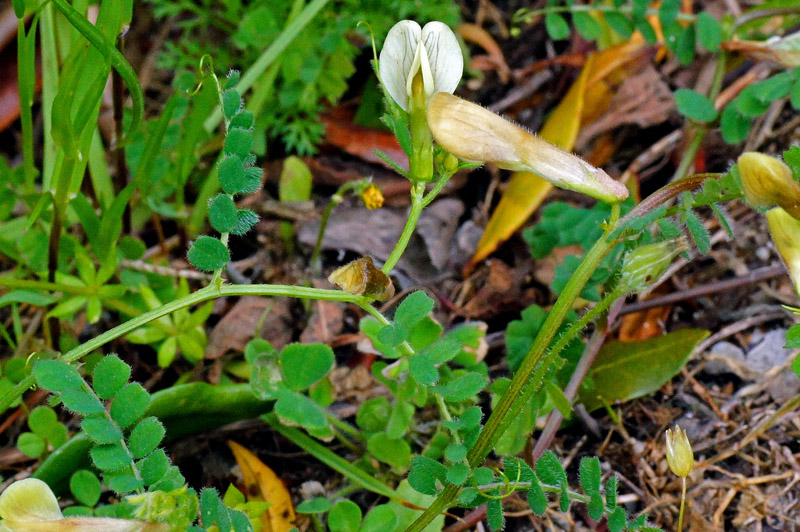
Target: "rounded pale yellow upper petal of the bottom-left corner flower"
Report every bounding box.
[0,478,63,520]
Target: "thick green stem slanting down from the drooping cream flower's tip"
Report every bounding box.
[406,222,618,532]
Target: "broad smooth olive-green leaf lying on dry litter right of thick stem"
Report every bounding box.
[580,328,709,411]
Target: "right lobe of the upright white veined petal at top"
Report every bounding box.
[422,21,464,96]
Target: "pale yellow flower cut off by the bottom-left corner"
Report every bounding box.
[0,478,169,532]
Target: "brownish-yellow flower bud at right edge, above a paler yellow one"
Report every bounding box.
[737,152,800,220]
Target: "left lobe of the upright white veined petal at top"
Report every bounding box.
[378,20,422,110]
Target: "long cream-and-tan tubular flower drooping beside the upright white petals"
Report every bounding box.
[428,92,628,203]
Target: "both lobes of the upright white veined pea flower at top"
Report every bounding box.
[379,20,464,111]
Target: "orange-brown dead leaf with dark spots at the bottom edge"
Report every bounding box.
[228,440,295,532]
